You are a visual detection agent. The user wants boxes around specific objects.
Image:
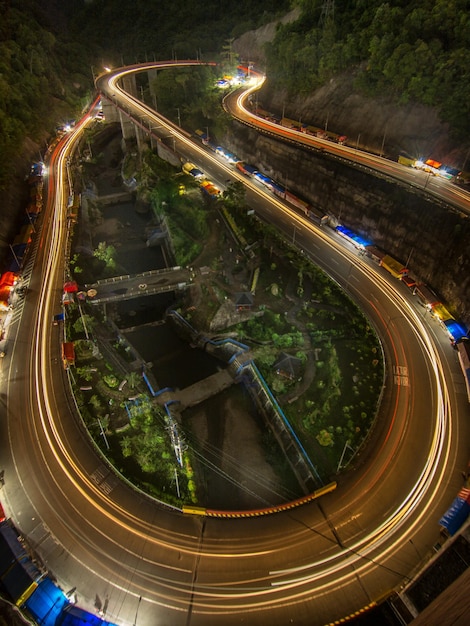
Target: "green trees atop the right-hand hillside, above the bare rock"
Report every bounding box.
[265,0,470,140]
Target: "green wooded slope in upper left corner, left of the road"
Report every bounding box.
[0,0,92,189]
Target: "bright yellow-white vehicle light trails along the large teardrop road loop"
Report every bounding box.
[21,63,452,613]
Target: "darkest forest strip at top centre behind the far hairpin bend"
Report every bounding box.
[69,0,291,63]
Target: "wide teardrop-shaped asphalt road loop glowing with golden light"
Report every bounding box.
[1,62,469,626]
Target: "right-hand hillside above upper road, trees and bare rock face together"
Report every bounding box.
[233,0,470,170]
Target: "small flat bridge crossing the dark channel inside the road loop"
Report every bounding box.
[85,266,194,304]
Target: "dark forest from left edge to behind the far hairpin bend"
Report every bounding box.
[0,0,290,191]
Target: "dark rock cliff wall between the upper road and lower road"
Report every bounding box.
[224,122,470,325]
